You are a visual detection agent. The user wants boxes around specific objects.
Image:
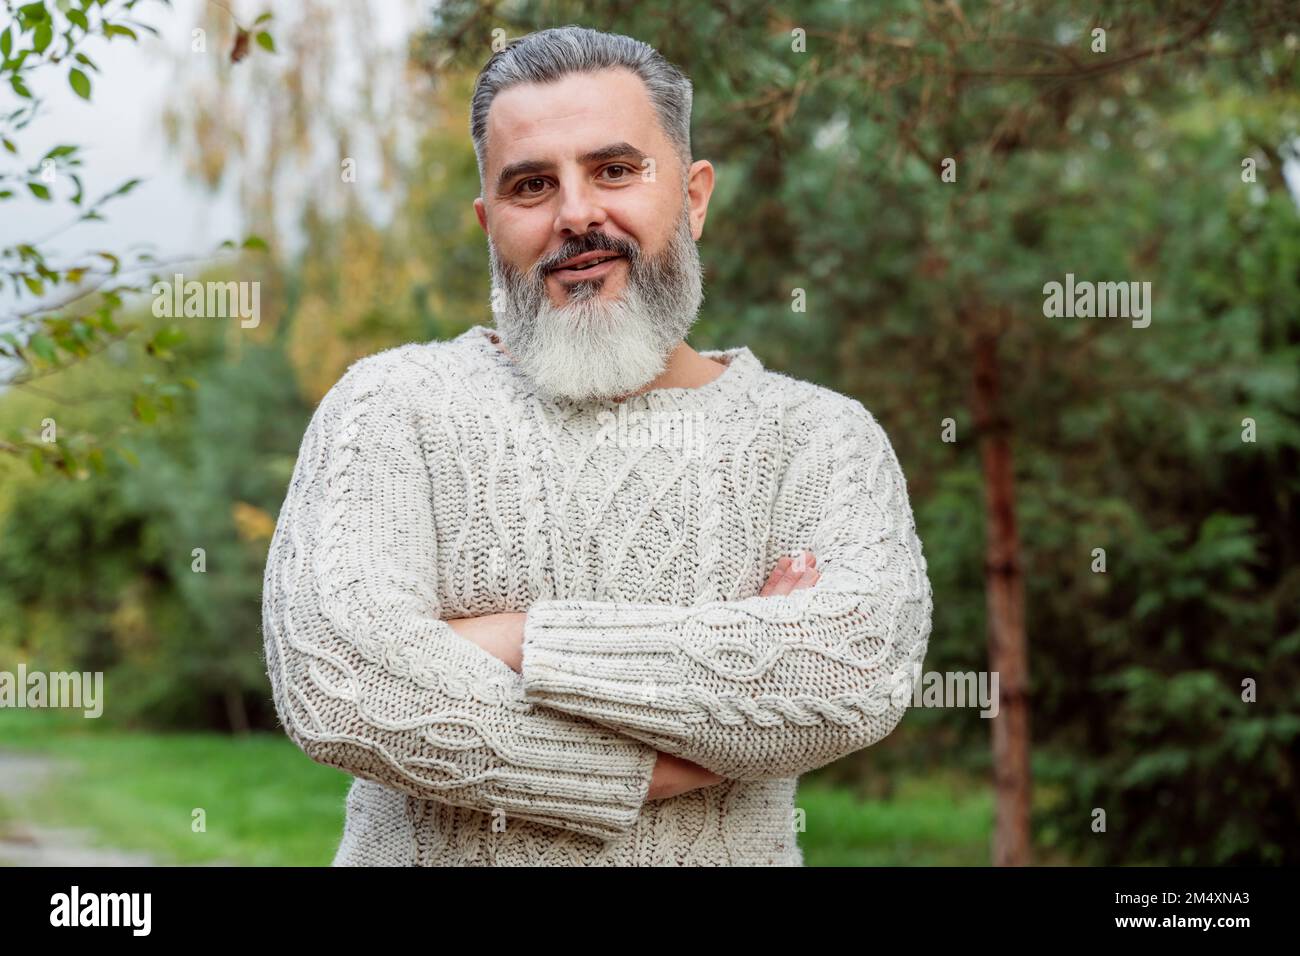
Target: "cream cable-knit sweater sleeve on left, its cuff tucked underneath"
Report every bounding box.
[263,359,658,839]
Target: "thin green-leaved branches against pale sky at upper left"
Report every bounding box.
[0,0,273,477]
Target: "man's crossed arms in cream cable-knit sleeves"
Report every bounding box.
[263,363,931,839]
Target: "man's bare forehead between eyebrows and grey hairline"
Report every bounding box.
[488,69,667,169]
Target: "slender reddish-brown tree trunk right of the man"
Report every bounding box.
[972,332,1032,866]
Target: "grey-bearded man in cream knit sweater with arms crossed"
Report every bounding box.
[264,27,931,866]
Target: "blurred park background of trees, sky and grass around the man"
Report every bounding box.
[0,0,1300,865]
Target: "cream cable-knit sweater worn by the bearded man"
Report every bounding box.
[263,326,932,866]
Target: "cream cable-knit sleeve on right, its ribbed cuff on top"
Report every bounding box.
[523,399,932,780]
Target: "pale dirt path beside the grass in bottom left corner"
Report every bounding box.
[0,750,157,866]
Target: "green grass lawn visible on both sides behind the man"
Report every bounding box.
[0,710,993,866]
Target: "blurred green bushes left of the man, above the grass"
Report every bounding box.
[0,291,311,730]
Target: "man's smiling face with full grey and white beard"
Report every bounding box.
[475,63,712,399]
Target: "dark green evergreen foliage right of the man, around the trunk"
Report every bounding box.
[416,0,1300,864]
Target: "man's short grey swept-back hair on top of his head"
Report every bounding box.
[469,25,692,187]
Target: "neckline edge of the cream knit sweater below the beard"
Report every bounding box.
[463,325,763,411]
